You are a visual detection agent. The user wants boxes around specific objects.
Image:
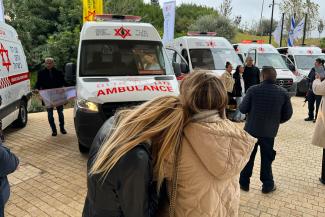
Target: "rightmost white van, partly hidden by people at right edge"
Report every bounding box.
[278,47,325,94]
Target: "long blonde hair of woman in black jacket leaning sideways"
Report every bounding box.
[89,96,186,191]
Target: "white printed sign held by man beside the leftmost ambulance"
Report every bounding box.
[39,87,77,108]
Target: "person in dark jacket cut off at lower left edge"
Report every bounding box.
[0,143,19,217]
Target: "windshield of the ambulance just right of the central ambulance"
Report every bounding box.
[190,48,242,70]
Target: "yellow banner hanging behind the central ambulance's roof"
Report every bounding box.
[83,0,104,22]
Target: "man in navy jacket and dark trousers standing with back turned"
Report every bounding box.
[239,67,292,193]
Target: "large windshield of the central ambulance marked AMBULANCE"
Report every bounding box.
[80,40,173,76]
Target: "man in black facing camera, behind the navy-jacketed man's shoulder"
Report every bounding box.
[243,56,260,92]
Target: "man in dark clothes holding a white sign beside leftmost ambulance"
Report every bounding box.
[35,58,67,136]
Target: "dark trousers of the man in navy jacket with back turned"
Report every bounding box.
[239,137,276,189]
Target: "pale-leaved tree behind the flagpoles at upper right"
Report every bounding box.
[280,0,319,35]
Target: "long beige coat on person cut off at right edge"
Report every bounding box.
[312,79,325,148]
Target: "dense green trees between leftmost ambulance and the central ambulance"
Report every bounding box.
[4,0,82,71]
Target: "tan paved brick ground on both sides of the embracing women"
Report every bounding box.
[5,98,325,217]
